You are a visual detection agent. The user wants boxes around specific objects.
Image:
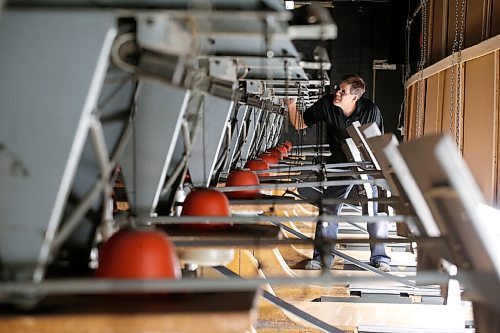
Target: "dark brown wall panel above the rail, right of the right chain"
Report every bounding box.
[459,0,490,47]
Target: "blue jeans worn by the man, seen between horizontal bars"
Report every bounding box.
[299,182,391,267]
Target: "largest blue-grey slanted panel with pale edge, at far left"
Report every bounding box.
[0,9,116,280]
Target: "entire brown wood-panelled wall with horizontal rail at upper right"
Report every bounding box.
[405,0,500,204]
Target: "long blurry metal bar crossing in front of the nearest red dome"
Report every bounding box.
[0,271,458,301]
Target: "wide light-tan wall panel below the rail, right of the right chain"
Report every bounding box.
[463,53,497,202]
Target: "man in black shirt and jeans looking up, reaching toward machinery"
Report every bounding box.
[285,74,391,272]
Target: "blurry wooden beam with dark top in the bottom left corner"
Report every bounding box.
[0,291,257,333]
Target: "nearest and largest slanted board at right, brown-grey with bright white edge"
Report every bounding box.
[387,136,500,332]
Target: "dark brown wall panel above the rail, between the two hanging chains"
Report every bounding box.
[429,0,448,64]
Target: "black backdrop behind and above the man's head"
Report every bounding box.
[283,0,420,144]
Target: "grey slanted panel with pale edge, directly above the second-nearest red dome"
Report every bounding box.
[120,79,190,216]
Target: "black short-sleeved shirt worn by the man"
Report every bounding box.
[304,95,384,163]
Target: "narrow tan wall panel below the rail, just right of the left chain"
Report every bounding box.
[424,73,442,135]
